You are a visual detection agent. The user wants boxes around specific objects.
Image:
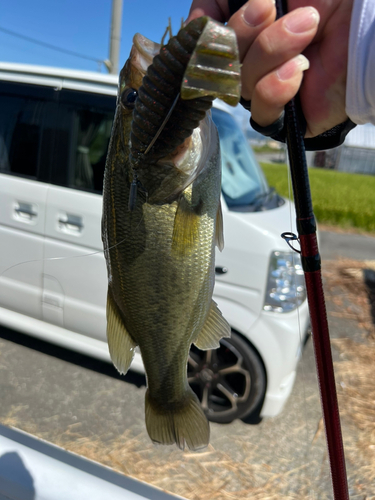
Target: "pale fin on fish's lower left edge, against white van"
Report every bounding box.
[107,289,137,375]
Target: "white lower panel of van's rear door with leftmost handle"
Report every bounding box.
[0,175,48,318]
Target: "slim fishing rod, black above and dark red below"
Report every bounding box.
[228,0,354,500]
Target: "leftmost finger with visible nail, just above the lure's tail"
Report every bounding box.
[228,0,276,62]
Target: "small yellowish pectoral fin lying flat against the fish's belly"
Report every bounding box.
[172,196,199,256]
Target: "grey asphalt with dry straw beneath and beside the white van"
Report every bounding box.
[0,231,375,500]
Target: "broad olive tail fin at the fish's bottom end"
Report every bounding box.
[145,388,210,450]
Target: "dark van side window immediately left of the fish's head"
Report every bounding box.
[51,90,116,193]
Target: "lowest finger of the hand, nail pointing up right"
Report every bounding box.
[251,54,309,127]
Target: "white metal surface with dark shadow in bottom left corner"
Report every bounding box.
[0,425,182,500]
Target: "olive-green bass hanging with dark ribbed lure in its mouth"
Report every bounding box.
[102,17,241,450]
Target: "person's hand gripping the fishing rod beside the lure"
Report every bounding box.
[188,0,353,137]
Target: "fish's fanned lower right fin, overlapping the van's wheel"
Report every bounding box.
[194,301,231,351]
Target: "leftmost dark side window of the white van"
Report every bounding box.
[0,82,57,182]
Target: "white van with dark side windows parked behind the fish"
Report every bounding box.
[0,63,309,422]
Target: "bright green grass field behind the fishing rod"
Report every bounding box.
[261,163,375,232]
